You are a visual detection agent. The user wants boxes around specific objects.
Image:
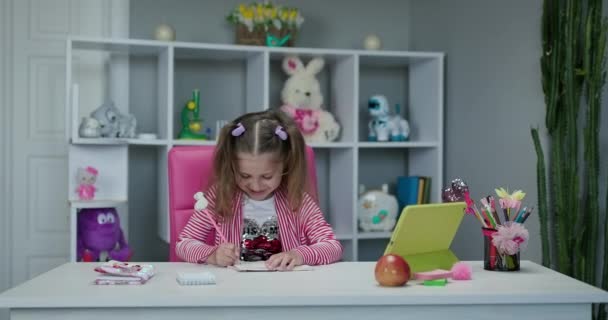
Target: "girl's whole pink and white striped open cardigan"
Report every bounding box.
[175,187,343,265]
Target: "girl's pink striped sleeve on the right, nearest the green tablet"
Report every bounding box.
[294,194,343,265]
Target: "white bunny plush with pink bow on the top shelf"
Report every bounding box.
[281,56,340,143]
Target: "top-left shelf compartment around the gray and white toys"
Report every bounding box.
[66,40,170,143]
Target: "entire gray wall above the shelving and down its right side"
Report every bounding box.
[130,0,608,262]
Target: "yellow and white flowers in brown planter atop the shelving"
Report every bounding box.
[226,2,304,46]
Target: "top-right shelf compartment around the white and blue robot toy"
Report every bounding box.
[358,53,443,143]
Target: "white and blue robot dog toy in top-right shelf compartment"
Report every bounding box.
[368,95,410,141]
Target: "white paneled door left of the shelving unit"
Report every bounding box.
[2,0,129,286]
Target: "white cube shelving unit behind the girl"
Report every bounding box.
[66,37,444,260]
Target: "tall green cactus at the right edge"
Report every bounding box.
[531,0,608,320]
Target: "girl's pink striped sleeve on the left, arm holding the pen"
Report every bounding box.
[175,188,217,263]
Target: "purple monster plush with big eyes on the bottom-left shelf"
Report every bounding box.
[76,208,133,262]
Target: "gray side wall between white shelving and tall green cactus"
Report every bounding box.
[412,0,545,262]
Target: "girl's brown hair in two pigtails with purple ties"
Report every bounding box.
[211,110,308,217]
